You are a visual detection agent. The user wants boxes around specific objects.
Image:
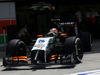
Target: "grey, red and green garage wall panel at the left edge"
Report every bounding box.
[0,2,16,47]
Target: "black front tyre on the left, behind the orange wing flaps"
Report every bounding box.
[6,39,27,57]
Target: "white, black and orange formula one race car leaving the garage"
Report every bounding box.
[3,22,90,66]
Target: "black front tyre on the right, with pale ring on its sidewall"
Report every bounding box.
[63,37,83,63]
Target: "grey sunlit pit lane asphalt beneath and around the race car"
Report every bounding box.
[0,39,100,75]
